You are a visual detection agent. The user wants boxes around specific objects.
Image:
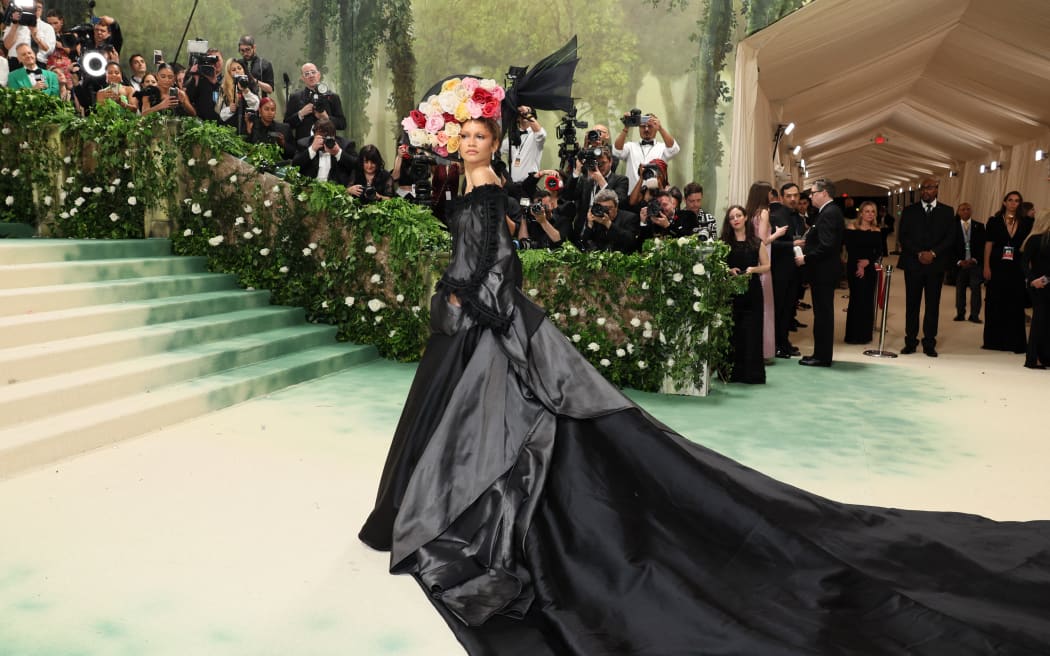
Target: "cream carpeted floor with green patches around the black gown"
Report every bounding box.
[0,354,1050,656]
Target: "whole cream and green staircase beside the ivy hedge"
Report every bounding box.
[0,239,378,479]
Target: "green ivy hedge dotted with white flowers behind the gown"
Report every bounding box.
[0,88,741,390]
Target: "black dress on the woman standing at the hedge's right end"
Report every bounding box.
[726,241,765,384]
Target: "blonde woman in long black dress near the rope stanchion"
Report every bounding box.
[843,200,882,344]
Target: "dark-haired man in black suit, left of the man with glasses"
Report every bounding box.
[770,183,805,359]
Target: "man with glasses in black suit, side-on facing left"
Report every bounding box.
[795,177,845,366]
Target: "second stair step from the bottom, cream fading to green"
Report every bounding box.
[0,324,336,427]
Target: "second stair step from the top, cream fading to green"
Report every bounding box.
[0,251,208,290]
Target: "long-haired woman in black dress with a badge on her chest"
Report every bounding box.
[982,191,1032,353]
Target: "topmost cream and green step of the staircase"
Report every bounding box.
[0,238,171,264]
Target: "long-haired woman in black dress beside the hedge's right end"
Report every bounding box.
[720,205,770,383]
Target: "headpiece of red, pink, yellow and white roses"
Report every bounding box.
[401,78,506,157]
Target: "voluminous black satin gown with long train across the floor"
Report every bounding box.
[360,186,1050,656]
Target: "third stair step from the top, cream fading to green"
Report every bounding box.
[0,273,236,316]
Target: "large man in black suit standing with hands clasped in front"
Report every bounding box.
[898,178,958,358]
